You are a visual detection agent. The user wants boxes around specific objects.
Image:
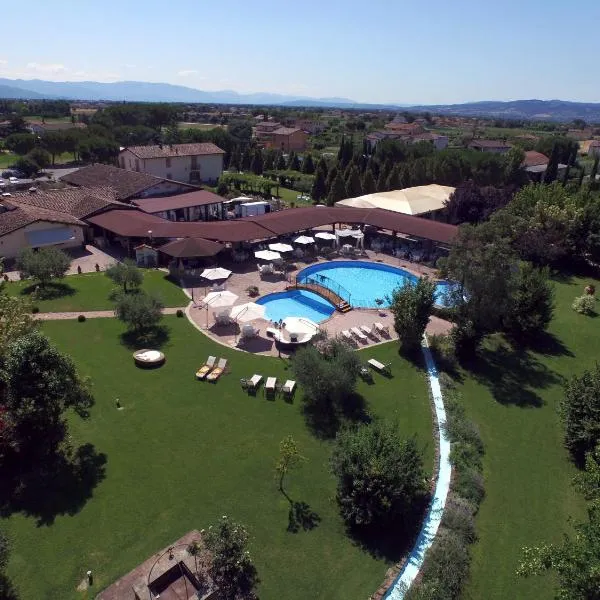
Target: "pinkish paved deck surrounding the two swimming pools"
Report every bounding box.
[184,250,452,356]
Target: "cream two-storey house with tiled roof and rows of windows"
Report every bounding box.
[119,143,225,183]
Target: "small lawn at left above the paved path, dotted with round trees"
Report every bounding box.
[5,271,187,312]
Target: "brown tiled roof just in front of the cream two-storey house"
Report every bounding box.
[61,164,197,200]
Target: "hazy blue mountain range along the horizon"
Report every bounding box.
[0,78,600,122]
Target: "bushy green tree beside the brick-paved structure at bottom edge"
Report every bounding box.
[204,515,259,600]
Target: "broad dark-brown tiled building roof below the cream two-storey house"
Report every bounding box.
[61,164,198,202]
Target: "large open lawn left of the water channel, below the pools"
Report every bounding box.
[2,317,433,600]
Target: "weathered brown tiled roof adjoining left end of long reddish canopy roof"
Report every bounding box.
[10,187,129,219]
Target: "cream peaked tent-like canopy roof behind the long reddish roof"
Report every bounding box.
[336,184,455,215]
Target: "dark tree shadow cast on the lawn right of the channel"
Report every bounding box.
[465,344,564,408]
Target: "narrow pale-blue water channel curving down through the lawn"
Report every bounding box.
[385,337,452,600]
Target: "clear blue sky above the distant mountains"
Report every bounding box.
[0,0,600,104]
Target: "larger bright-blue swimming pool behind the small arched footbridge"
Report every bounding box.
[297,260,449,308]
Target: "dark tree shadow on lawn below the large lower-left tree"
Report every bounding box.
[0,444,107,527]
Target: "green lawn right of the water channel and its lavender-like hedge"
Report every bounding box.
[450,278,600,600]
